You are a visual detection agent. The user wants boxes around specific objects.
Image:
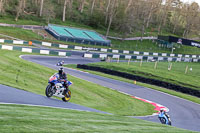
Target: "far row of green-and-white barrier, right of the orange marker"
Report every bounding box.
[32,40,200,59]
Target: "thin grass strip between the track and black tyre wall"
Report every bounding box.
[65,64,200,104]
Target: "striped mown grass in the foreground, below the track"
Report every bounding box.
[0,104,196,133]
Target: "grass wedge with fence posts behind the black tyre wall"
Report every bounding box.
[84,62,200,90]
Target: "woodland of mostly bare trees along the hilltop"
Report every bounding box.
[0,0,200,38]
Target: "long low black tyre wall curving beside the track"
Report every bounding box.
[77,64,200,98]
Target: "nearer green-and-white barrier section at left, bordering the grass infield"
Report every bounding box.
[0,44,71,56]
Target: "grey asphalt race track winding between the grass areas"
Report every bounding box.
[0,54,200,131]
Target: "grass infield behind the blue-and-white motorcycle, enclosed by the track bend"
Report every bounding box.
[0,50,155,116]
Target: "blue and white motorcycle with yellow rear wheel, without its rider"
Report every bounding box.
[45,74,72,102]
